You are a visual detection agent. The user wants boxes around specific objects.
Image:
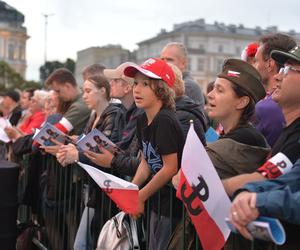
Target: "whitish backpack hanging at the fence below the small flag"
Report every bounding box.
[96,212,140,250]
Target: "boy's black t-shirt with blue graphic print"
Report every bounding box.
[137,109,184,217]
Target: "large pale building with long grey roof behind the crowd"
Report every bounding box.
[136,19,300,89]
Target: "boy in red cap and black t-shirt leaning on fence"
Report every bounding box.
[124,58,184,249]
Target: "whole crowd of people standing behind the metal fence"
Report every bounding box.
[0,33,300,250]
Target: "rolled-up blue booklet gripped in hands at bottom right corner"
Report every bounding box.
[226,216,286,245]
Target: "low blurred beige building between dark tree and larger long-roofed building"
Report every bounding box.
[75,45,133,84]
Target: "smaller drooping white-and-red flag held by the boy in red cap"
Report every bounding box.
[78,162,139,214]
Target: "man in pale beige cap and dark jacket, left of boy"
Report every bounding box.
[85,62,143,176]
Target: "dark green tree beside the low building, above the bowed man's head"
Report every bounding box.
[40,58,75,83]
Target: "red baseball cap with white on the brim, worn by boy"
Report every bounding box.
[124,58,175,88]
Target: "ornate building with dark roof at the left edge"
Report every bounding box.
[0,1,29,78]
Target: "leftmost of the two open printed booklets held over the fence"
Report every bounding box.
[33,123,72,146]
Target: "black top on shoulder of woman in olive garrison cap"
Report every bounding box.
[221,124,267,147]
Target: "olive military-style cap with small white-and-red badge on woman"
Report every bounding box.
[218,59,266,103]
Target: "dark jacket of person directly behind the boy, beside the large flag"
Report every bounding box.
[175,96,206,145]
